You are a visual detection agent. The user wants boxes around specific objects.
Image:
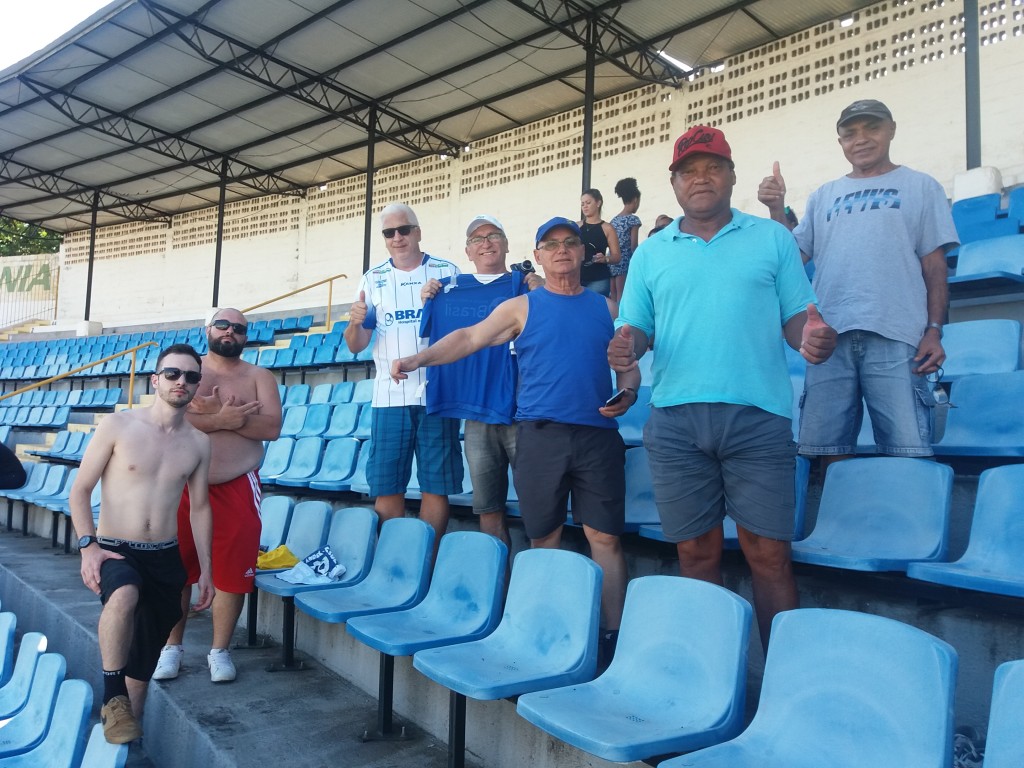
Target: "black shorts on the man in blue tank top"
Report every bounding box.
[513,421,626,539]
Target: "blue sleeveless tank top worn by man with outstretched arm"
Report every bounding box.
[515,288,618,429]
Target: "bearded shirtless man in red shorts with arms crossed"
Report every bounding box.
[153,309,282,683]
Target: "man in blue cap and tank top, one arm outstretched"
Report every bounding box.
[391,217,640,660]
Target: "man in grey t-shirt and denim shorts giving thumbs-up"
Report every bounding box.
[758,99,957,462]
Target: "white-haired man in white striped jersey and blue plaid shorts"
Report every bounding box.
[345,203,462,551]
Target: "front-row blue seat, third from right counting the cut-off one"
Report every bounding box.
[516,575,752,762]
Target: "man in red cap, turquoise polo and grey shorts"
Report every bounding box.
[608,126,836,648]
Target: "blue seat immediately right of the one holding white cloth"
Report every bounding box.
[295,517,434,624]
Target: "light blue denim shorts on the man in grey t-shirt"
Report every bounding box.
[800,331,935,457]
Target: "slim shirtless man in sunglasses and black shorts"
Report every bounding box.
[70,344,213,743]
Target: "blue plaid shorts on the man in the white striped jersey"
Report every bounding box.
[367,406,463,496]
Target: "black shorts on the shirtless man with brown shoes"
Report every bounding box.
[99,542,186,680]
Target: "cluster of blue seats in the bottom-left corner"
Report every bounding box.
[0,612,128,768]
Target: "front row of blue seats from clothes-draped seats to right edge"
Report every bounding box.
[250,500,1024,768]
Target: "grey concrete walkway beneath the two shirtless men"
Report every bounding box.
[0,526,468,768]
